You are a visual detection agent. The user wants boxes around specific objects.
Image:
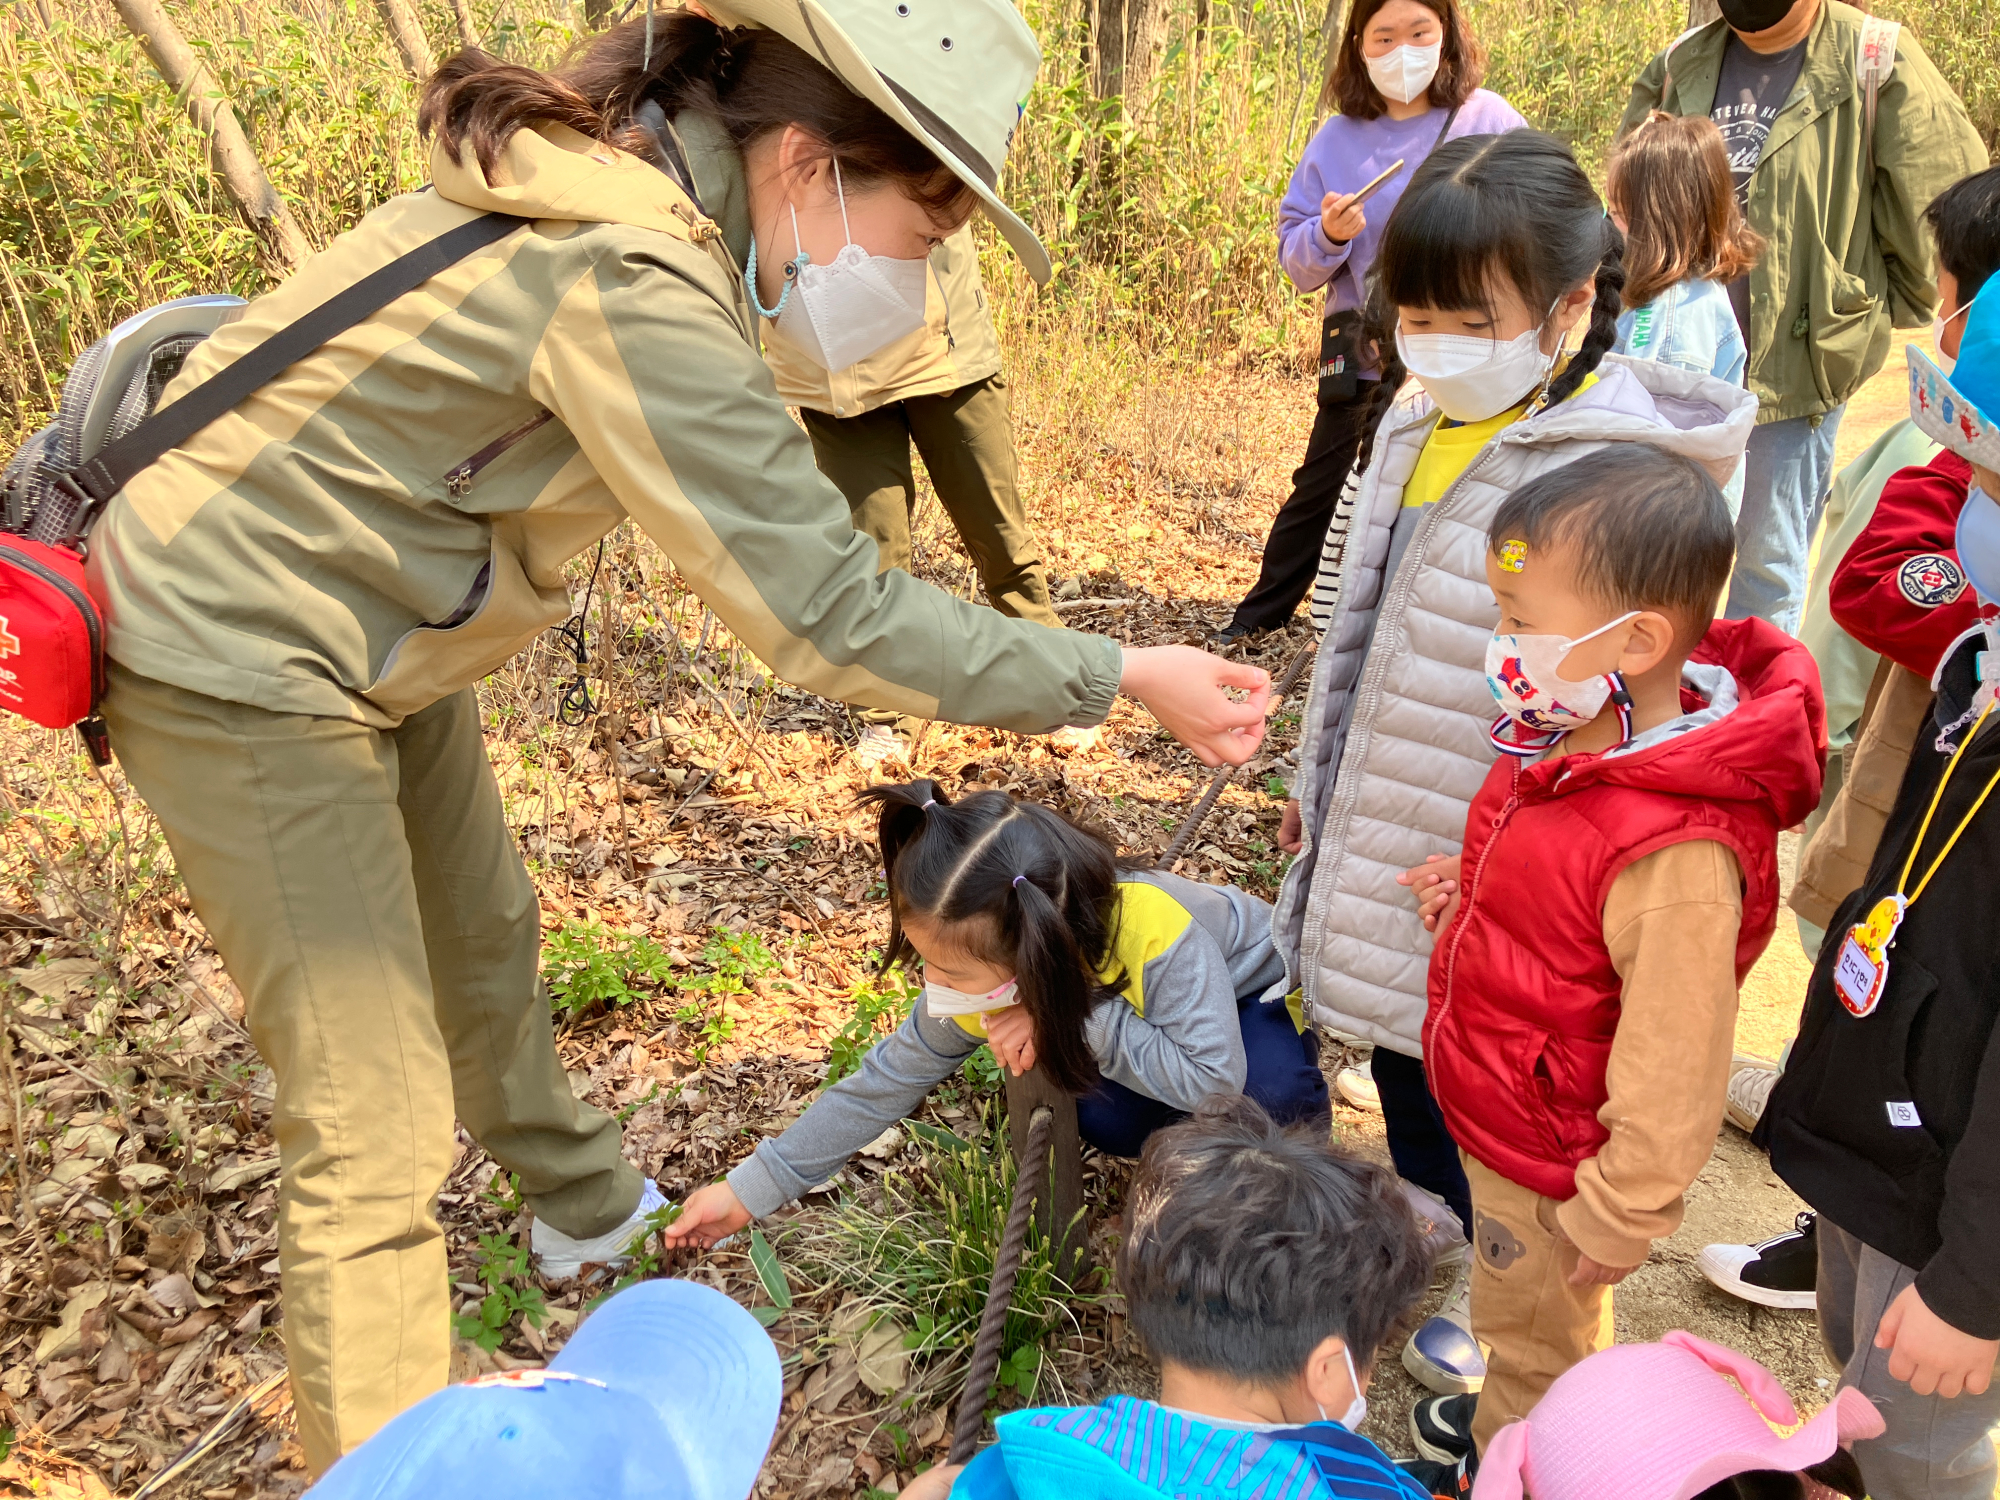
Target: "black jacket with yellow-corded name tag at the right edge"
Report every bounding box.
[1756,636,2000,1338]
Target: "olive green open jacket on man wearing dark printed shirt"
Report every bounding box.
[1618,0,1986,422]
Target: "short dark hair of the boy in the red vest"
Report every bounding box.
[1486,452,1736,648]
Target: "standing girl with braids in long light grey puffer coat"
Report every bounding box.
[1272,130,1756,1394]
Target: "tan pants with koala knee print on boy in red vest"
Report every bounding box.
[1458,1152,1612,1454]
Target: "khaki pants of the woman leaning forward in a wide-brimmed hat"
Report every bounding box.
[104,664,640,1474]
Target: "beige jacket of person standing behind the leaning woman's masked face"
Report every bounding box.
[758,224,1000,416]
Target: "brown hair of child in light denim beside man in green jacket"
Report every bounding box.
[1604,110,1764,308]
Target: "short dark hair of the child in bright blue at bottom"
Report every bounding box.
[1118,1096,1430,1384]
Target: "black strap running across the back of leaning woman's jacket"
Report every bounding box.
[56,214,530,520]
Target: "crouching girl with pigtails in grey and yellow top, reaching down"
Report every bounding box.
[666,782,1332,1244]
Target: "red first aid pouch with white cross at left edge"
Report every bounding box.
[0,532,104,756]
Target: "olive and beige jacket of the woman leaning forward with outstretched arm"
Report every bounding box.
[90,116,1120,730]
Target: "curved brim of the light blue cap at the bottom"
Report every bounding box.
[564,1280,784,1500]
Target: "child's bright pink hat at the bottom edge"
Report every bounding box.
[1472,1330,1882,1500]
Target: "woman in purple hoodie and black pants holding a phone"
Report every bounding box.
[1208,0,1526,646]
